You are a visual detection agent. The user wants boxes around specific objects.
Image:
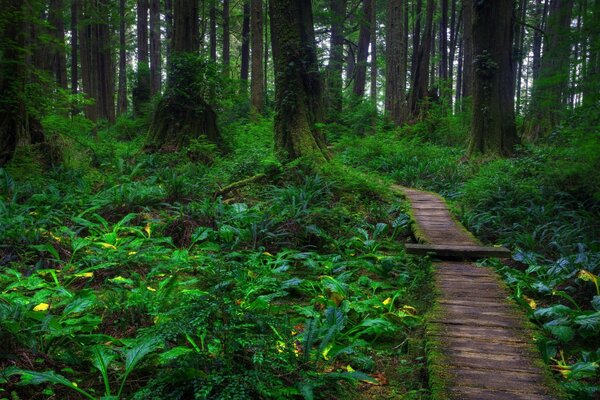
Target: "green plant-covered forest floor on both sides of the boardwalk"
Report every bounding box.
[0,113,600,400]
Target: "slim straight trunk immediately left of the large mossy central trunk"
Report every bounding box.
[250,0,265,114]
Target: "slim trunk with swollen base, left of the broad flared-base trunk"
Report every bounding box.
[133,0,152,115]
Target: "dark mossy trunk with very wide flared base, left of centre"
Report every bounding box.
[146,0,222,151]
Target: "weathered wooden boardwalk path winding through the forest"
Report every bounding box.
[392,186,560,400]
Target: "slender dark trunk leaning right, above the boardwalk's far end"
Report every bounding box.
[409,0,435,117]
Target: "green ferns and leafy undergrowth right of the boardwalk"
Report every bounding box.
[337,111,600,399]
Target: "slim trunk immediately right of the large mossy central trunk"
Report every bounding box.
[325,0,346,122]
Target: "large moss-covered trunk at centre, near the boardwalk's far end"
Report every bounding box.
[269,0,328,162]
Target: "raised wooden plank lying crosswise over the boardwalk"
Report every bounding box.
[405,243,510,259]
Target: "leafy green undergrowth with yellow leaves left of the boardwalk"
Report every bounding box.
[0,120,430,400]
